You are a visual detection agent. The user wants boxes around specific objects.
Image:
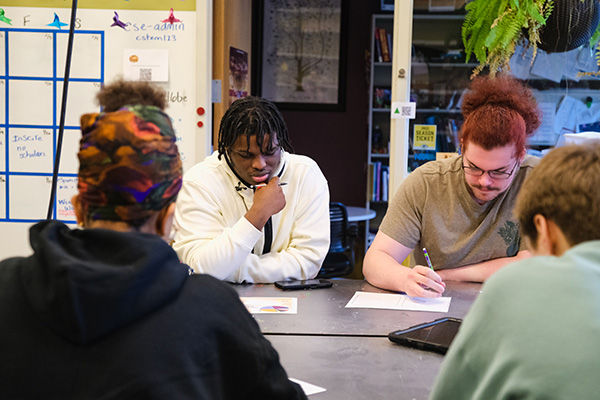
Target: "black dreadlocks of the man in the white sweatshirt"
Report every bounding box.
[219,96,294,159]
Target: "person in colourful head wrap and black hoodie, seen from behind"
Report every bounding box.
[0,83,306,399]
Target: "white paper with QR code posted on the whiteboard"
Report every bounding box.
[123,49,169,82]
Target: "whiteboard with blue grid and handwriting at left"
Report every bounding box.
[0,0,212,259]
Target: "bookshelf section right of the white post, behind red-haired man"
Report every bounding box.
[406,9,468,173]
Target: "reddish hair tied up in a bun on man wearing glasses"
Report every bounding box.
[461,75,541,155]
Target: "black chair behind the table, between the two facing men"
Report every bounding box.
[317,203,356,278]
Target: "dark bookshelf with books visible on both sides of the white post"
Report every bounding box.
[367,10,468,233]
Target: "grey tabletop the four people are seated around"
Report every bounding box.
[234,279,481,400]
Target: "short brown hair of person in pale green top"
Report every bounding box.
[514,142,600,246]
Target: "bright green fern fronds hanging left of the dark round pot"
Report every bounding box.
[462,0,554,76]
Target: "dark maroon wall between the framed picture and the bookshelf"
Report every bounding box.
[282,0,381,207]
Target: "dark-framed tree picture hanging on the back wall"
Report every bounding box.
[256,0,347,111]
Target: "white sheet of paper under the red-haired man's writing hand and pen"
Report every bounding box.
[346,292,452,312]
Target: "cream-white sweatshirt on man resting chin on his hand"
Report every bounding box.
[173,151,330,283]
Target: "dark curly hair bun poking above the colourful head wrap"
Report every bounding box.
[96,79,167,112]
